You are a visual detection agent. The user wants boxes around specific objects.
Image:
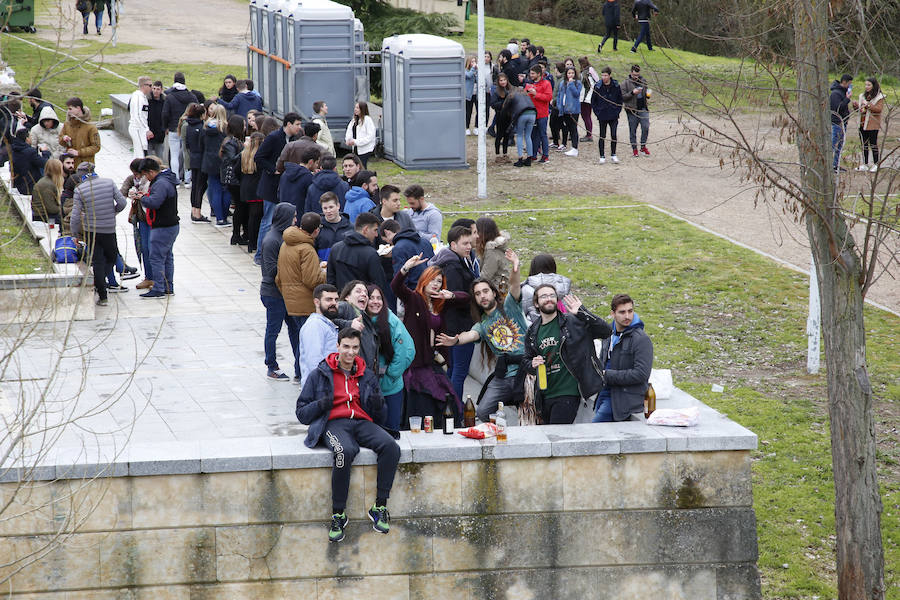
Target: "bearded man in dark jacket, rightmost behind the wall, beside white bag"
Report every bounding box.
[593,294,653,423]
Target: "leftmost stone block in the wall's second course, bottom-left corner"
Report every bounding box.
[0,533,105,592]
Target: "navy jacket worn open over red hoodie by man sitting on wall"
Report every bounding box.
[296,352,387,448]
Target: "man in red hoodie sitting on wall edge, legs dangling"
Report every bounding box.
[297,327,400,542]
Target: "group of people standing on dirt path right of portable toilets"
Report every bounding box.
[465,39,652,167]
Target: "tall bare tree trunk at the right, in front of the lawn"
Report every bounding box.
[794,0,885,600]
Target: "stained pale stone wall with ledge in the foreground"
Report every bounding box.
[0,421,760,600]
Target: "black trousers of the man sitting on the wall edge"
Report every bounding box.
[322,419,400,512]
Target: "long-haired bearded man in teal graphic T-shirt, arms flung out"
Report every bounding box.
[436,250,528,423]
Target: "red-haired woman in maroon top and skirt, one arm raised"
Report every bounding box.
[391,254,469,429]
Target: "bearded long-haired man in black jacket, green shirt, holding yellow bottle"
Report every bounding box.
[521,284,612,424]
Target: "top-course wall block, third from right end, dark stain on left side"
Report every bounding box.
[459,458,564,515]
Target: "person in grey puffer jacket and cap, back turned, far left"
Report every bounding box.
[69,162,127,306]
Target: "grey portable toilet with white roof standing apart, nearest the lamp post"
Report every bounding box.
[382,33,468,169]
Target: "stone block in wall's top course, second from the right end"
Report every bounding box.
[563,453,674,511]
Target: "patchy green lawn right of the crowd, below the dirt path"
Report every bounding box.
[448,196,900,600]
